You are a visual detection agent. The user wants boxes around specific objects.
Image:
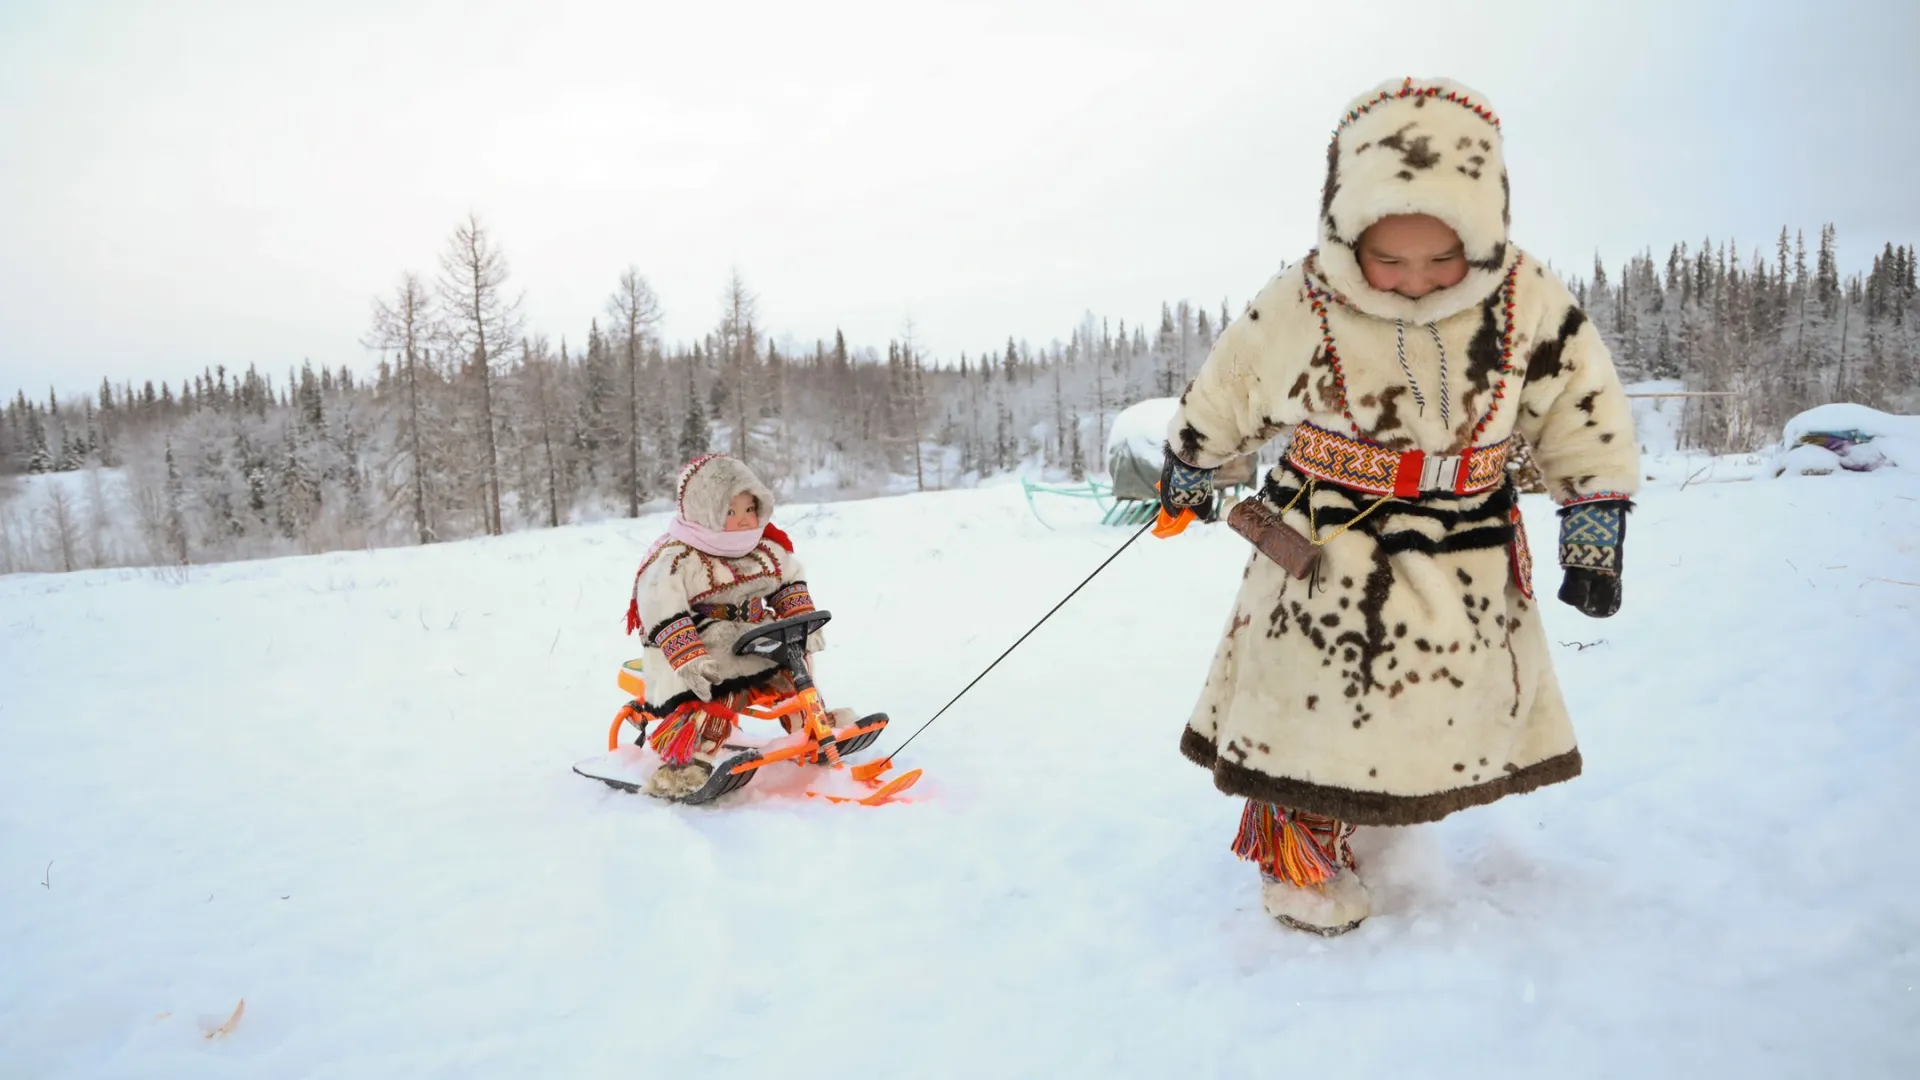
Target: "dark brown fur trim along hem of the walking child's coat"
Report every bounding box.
[1181,728,1582,824]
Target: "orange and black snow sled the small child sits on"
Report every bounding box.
[574,611,920,805]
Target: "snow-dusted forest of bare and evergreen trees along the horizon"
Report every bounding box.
[0,219,1920,573]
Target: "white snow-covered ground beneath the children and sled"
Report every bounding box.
[0,451,1920,1080]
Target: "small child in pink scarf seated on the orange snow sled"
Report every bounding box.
[626,454,852,799]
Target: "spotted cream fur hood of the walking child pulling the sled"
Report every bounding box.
[1315,79,1517,323]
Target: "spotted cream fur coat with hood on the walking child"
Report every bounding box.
[1167,81,1640,824]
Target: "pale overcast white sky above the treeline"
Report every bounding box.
[0,0,1920,396]
